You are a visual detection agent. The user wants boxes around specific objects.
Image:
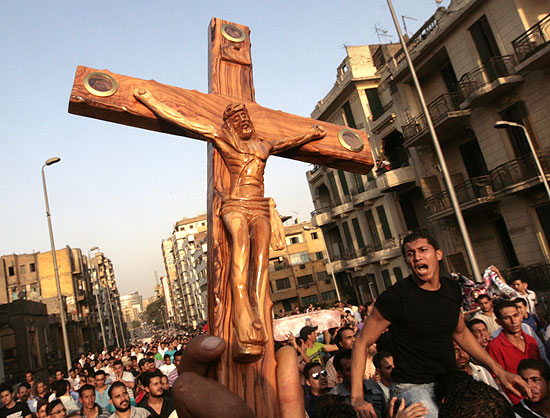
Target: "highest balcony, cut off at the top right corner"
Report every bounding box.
[512,14,550,71]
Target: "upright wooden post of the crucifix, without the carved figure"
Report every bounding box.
[207,18,279,418]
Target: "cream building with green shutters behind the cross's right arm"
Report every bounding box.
[306,44,416,303]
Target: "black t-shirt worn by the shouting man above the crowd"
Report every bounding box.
[374,276,462,383]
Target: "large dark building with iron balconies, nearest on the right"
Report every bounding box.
[369,0,550,286]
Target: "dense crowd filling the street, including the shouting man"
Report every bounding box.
[0,232,550,418]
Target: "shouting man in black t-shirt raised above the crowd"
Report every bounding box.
[351,232,529,418]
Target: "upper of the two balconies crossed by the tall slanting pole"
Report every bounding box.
[401,92,472,147]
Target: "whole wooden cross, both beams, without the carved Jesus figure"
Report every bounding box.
[69,18,373,418]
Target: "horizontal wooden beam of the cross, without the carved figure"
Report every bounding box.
[69,66,373,174]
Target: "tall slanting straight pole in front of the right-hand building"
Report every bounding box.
[386,0,482,283]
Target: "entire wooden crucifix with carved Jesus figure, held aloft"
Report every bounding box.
[69,18,373,418]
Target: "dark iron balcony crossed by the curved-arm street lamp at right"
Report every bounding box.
[489,151,550,194]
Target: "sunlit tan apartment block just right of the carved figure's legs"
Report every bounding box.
[269,222,338,315]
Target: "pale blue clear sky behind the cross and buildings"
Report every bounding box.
[0,0,448,297]
